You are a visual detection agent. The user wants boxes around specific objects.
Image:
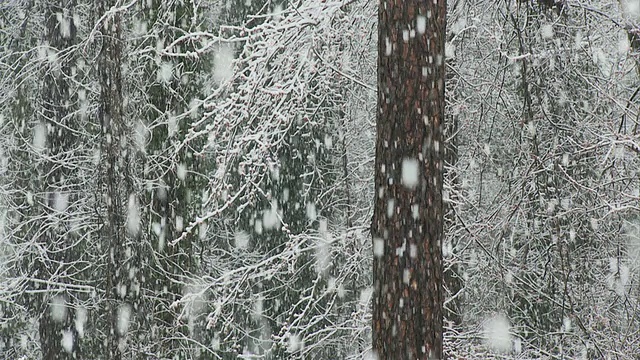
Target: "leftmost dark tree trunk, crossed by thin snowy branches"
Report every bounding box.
[35,0,80,360]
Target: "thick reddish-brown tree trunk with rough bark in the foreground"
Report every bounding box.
[371,0,446,359]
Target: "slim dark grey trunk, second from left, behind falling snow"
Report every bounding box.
[96,5,131,360]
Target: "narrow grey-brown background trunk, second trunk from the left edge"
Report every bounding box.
[95,1,134,360]
